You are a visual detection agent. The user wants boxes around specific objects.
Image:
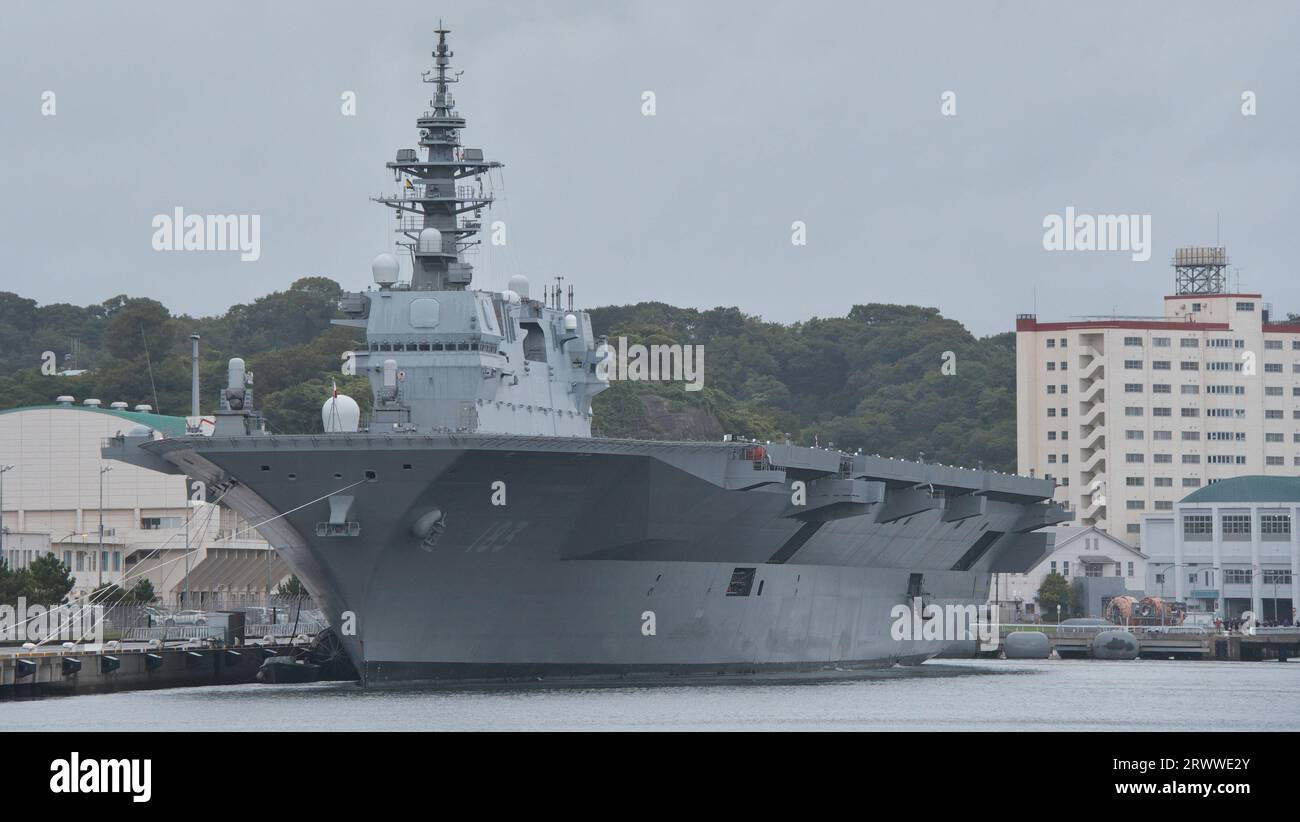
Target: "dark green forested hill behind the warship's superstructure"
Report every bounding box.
[0,277,1015,470]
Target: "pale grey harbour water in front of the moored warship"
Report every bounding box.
[0,661,1300,731]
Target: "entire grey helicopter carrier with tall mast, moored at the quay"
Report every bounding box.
[105,29,1069,684]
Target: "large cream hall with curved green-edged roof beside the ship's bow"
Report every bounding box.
[0,401,287,607]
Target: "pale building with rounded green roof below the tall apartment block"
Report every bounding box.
[1141,476,1300,623]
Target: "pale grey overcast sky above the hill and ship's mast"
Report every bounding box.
[0,0,1300,334]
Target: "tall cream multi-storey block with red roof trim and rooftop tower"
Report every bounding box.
[1015,248,1300,546]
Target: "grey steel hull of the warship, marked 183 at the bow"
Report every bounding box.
[114,436,1045,684]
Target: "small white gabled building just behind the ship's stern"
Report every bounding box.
[989,525,1147,622]
